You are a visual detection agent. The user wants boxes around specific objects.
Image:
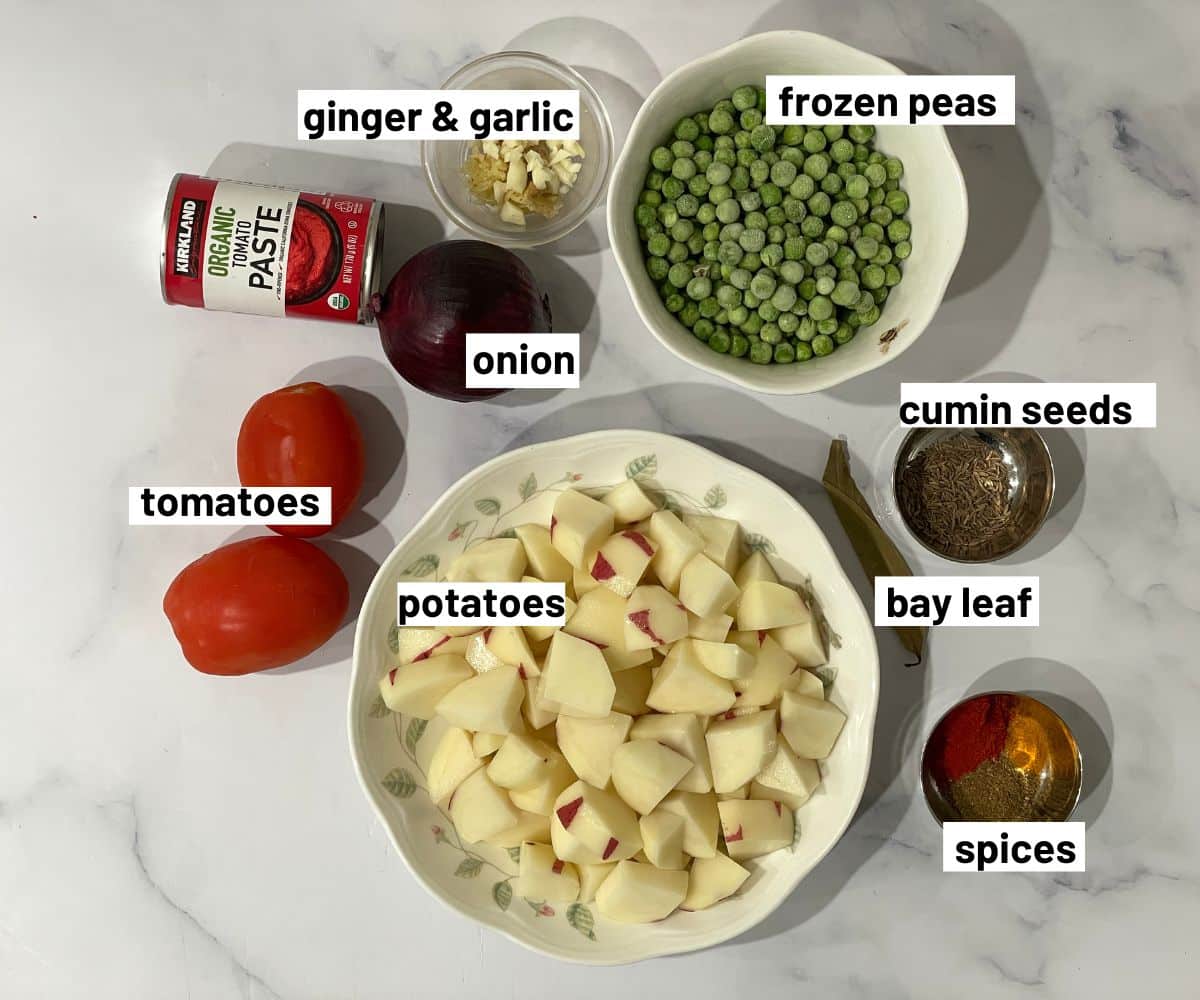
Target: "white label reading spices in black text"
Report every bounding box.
[942,822,1087,873]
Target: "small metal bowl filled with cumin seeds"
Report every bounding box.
[892,427,1054,563]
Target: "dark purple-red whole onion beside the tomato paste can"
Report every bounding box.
[371,240,552,401]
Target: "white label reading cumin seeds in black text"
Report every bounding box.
[900,382,1158,427]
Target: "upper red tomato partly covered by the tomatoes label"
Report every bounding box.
[238,382,364,538]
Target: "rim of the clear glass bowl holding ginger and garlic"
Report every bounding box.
[420,49,616,250]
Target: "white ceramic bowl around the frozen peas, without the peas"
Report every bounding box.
[608,31,967,394]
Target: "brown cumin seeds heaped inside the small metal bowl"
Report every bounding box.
[896,433,1013,549]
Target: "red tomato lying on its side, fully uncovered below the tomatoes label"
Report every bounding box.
[162,535,350,675]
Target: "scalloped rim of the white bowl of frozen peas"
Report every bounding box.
[606,29,970,396]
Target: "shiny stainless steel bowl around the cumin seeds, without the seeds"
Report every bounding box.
[892,427,1054,563]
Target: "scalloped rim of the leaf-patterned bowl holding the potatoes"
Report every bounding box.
[346,427,880,965]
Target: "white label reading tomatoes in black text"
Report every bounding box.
[130,486,334,526]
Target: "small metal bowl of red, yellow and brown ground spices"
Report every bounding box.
[920,691,1084,825]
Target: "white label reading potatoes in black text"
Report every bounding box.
[396,580,566,628]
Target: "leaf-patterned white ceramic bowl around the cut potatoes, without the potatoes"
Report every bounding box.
[349,431,880,965]
